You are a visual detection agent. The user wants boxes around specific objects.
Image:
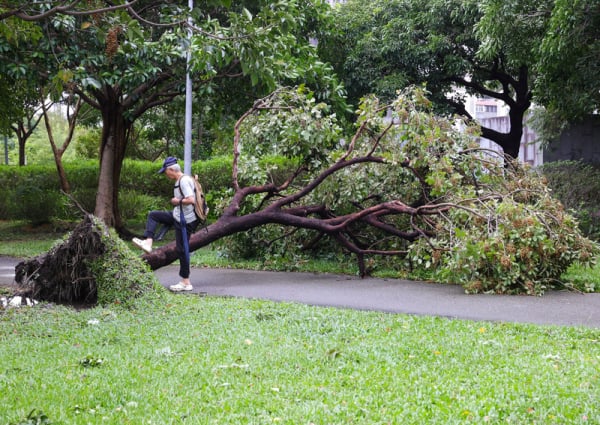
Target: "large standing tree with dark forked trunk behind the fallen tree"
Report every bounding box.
[319,0,545,158]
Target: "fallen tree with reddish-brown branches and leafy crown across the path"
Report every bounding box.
[144,89,598,294]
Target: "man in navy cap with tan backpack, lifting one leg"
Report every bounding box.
[133,156,199,292]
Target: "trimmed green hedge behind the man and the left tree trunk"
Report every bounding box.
[0,157,237,225]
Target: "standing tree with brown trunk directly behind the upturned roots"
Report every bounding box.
[0,0,339,231]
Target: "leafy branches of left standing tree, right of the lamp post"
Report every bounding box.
[192,0,345,108]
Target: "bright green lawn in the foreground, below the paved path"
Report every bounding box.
[0,294,600,424]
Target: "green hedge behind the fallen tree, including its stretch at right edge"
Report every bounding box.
[5,156,600,240]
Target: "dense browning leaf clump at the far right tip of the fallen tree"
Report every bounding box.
[429,195,598,295]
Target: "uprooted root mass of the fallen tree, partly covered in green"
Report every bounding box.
[15,214,157,305]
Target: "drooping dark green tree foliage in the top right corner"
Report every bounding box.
[478,0,600,131]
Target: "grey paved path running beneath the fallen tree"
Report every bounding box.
[0,257,600,329]
